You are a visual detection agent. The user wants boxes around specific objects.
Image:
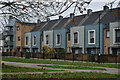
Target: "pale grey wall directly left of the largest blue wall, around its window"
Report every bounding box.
[70,26,84,53]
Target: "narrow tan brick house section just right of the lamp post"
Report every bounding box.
[104,27,110,54]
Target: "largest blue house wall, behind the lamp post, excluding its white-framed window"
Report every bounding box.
[85,24,105,54]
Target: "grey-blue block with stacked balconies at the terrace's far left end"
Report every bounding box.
[3,16,17,52]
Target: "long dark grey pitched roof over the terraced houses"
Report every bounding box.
[32,8,120,31]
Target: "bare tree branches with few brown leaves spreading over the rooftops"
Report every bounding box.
[0,0,92,29]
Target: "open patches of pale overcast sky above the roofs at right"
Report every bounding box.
[0,0,120,31]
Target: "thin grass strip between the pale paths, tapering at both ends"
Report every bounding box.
[38,65,106,70]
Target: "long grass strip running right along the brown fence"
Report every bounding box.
[2,57,120,68]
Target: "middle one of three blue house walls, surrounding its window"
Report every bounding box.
[53,29,67,52]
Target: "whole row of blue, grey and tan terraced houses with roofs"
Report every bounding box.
[3,7,120,54]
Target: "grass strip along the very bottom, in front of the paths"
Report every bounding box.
[2,72,120,80]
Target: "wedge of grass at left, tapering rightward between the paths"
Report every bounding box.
[2,65,61,73]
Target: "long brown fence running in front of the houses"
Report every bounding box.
[2,52,120,63]
